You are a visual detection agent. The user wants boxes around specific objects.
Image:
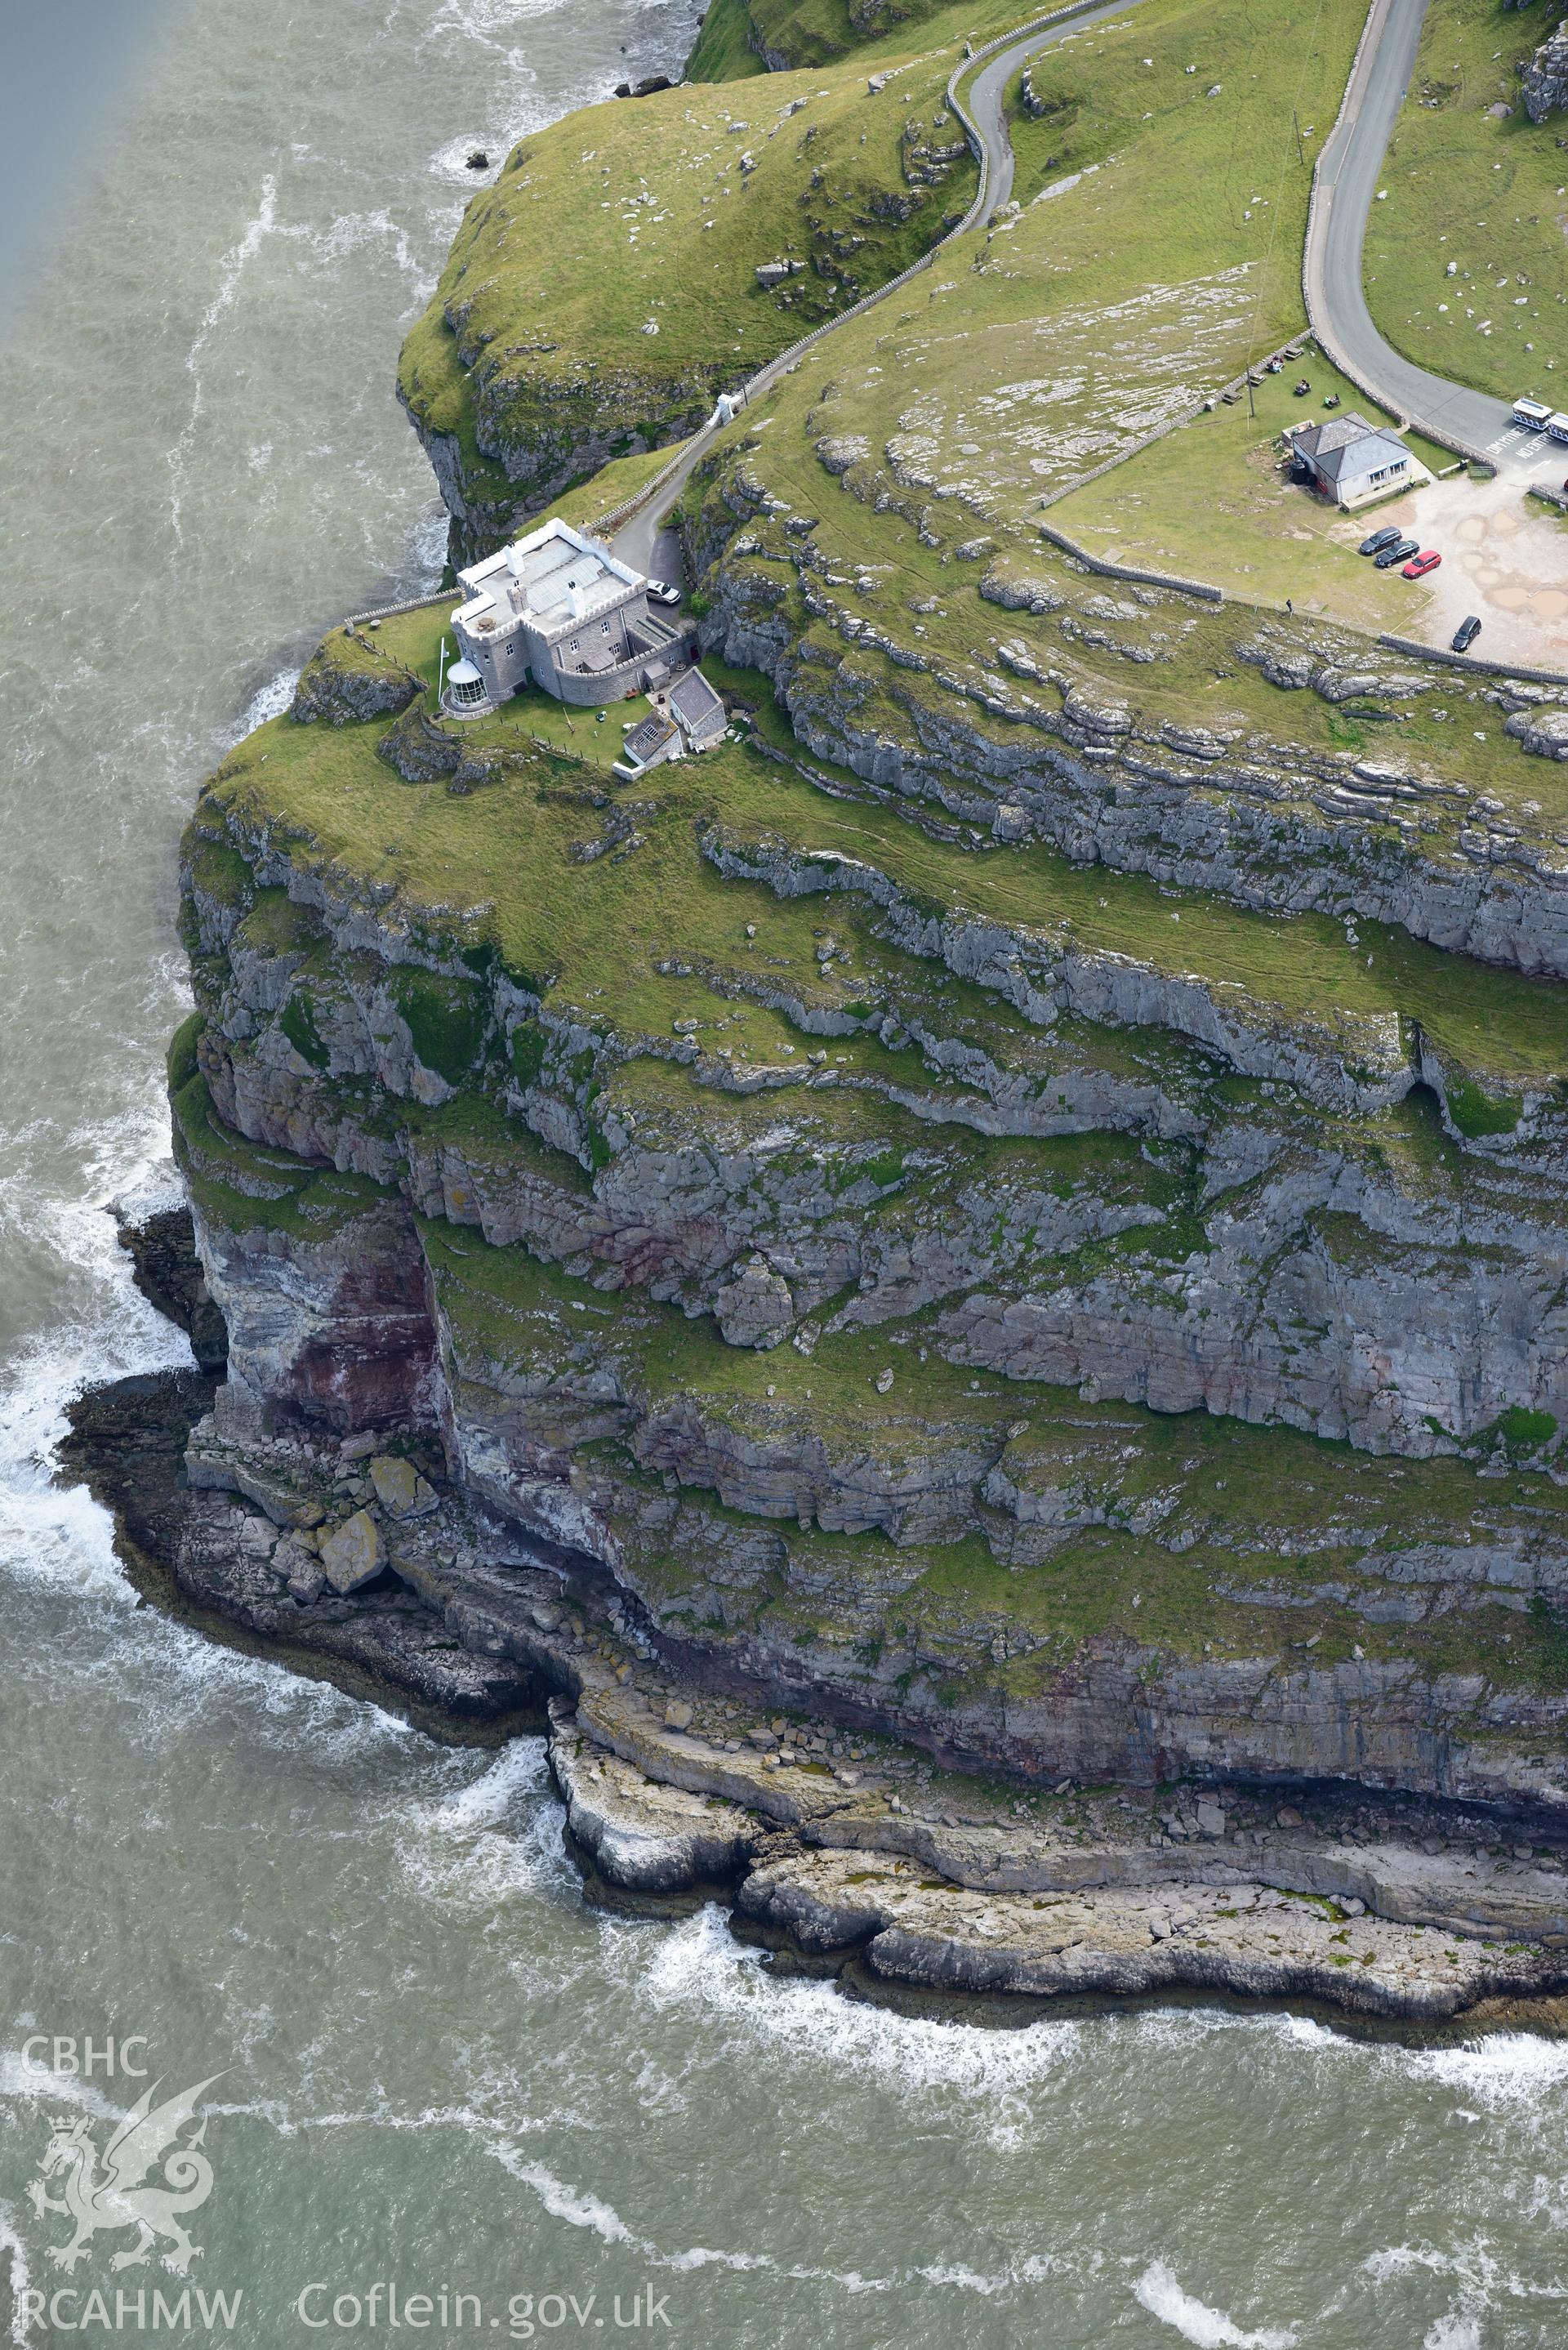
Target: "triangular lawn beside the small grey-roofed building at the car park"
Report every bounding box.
[1051,350,1450,632]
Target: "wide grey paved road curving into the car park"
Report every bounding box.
[1305,0,1552,472]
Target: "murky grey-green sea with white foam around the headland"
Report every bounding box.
[0,0,1568,2350]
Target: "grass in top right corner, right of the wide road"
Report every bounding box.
[1365,0,1568,402]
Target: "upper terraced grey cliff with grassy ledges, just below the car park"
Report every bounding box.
[696,453,1568,975]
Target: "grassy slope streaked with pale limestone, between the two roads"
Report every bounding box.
[677,0,1364,536]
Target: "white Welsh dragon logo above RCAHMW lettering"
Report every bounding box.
[29,2073,221,2277]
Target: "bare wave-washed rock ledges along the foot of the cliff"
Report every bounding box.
[55,1325,1568,2023]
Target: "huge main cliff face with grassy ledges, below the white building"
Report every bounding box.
[156,577,1568,1807]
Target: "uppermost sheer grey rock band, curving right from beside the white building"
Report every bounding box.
[698,456,1568,975]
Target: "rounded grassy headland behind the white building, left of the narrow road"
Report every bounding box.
[399,49,973,552]
